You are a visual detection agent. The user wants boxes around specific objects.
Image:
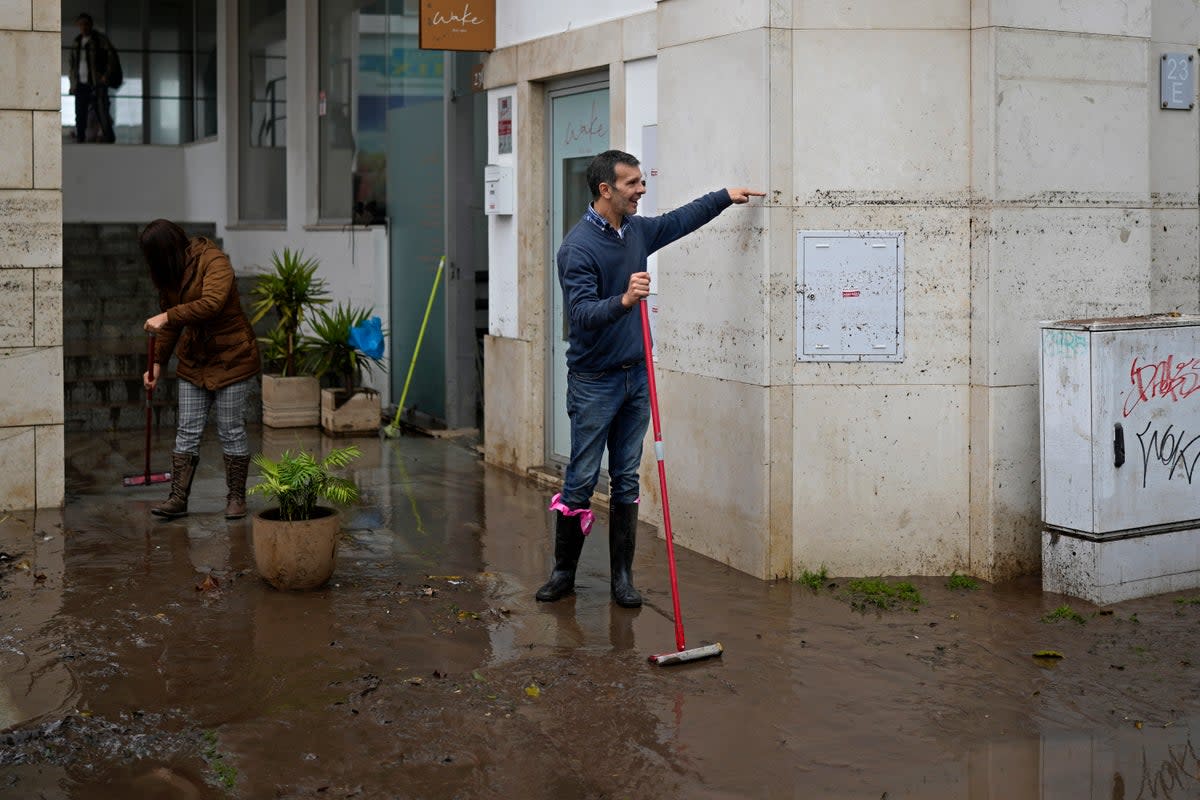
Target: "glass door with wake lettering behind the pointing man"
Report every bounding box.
[546,83,608,463]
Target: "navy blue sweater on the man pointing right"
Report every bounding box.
[558,190,733,373]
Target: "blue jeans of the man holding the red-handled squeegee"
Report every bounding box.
[563,361,650,509]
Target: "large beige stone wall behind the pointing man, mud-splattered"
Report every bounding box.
[477,0,1200,579]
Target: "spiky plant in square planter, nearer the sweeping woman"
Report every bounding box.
[250,247,329,428]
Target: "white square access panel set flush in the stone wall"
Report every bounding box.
[796,230,904,361]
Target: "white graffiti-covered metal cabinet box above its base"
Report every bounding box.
[1040,317,1200,537]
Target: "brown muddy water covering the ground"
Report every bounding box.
[0,432,1200,800]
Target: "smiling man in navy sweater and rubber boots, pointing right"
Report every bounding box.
[536,150,763,608]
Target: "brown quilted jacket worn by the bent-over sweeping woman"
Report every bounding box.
[155,236,260,390]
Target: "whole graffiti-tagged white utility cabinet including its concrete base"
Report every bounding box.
[1040,315,1200,602]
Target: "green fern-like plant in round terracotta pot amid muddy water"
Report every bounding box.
[250,445,361,589]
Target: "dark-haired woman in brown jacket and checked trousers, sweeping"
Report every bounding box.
[138,219,260,519]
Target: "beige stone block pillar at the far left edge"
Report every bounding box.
[0,0,64,510]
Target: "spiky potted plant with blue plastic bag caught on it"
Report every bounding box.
[305,303,386,434]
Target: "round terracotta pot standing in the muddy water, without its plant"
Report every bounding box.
[252,506,342,589]
